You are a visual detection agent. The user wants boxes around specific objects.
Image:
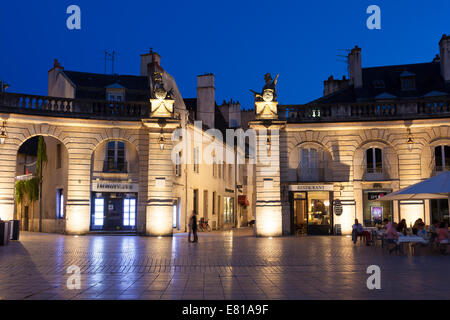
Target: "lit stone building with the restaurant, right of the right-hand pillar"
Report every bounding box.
[278,35,450,234]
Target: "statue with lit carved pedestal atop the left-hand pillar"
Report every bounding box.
[150,72,175,118]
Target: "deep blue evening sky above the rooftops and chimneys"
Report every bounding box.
[0,0,450,108]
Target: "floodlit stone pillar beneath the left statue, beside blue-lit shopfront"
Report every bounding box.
[143,119,179,236]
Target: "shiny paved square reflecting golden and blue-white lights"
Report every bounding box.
[0,230,450,300]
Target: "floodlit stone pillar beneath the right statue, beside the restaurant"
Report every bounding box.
[250,120,285,237]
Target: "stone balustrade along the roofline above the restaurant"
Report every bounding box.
[278,98,450,123]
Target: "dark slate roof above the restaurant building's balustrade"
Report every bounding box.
[310,61,450,104]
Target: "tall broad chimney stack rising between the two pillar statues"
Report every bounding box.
[197,73,216,128]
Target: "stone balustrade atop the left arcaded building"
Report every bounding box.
[0,93,150,120]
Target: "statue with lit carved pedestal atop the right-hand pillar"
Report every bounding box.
[250,73,279,119]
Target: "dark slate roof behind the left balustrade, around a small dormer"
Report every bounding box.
[63,70,150,102]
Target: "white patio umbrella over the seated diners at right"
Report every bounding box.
[379,171,450,204]
